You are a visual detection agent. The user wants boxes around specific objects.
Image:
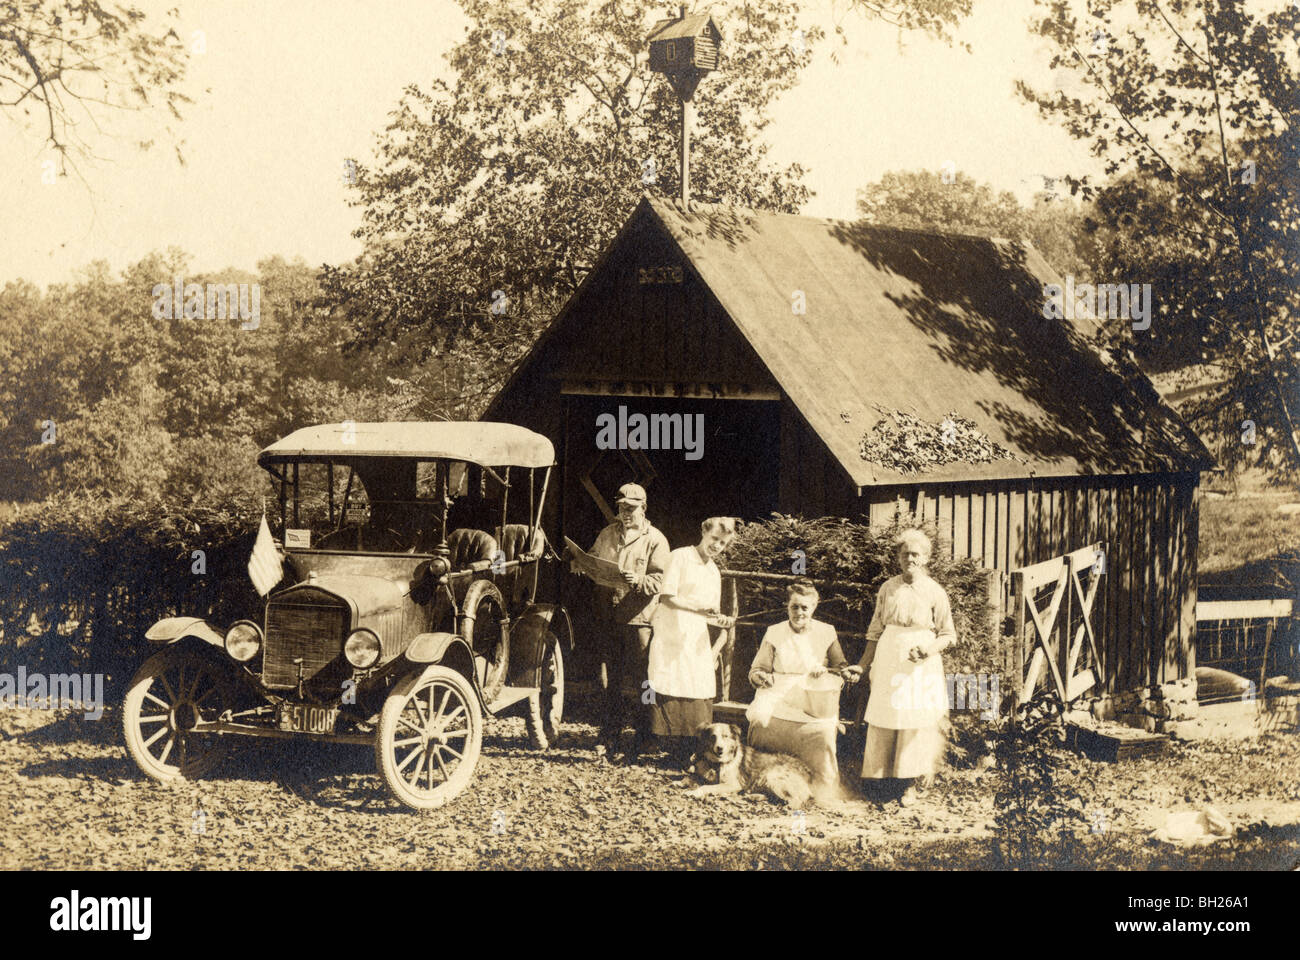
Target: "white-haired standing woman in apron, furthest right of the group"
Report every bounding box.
[852,529,957,807]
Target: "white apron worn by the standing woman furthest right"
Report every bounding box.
[866,624,948,730]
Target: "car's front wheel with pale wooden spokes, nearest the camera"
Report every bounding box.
[374,665,484,810]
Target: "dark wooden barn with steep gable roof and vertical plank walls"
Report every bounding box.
[484,196,1213,693]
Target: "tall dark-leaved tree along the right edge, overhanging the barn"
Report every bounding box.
[1019,0,1300,470]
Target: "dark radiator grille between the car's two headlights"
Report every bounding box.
[261,591,351,688]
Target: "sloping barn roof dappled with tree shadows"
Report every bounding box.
[493,196,1213,488]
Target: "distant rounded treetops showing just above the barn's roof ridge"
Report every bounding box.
[858,170,1088,274]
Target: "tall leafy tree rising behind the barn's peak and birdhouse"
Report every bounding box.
[322,0,967,414]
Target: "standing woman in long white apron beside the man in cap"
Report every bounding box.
[647,516,736,760]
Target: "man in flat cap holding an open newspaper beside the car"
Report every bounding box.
[590,484,668,764]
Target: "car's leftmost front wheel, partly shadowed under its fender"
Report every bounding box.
[122,647,230,782]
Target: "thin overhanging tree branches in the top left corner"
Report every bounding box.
[0,0,191,174]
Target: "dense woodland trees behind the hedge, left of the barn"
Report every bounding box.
[0,250,395,507]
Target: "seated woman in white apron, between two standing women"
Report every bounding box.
[745,581,848,797]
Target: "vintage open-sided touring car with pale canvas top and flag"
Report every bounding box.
[124,421,573,809]
